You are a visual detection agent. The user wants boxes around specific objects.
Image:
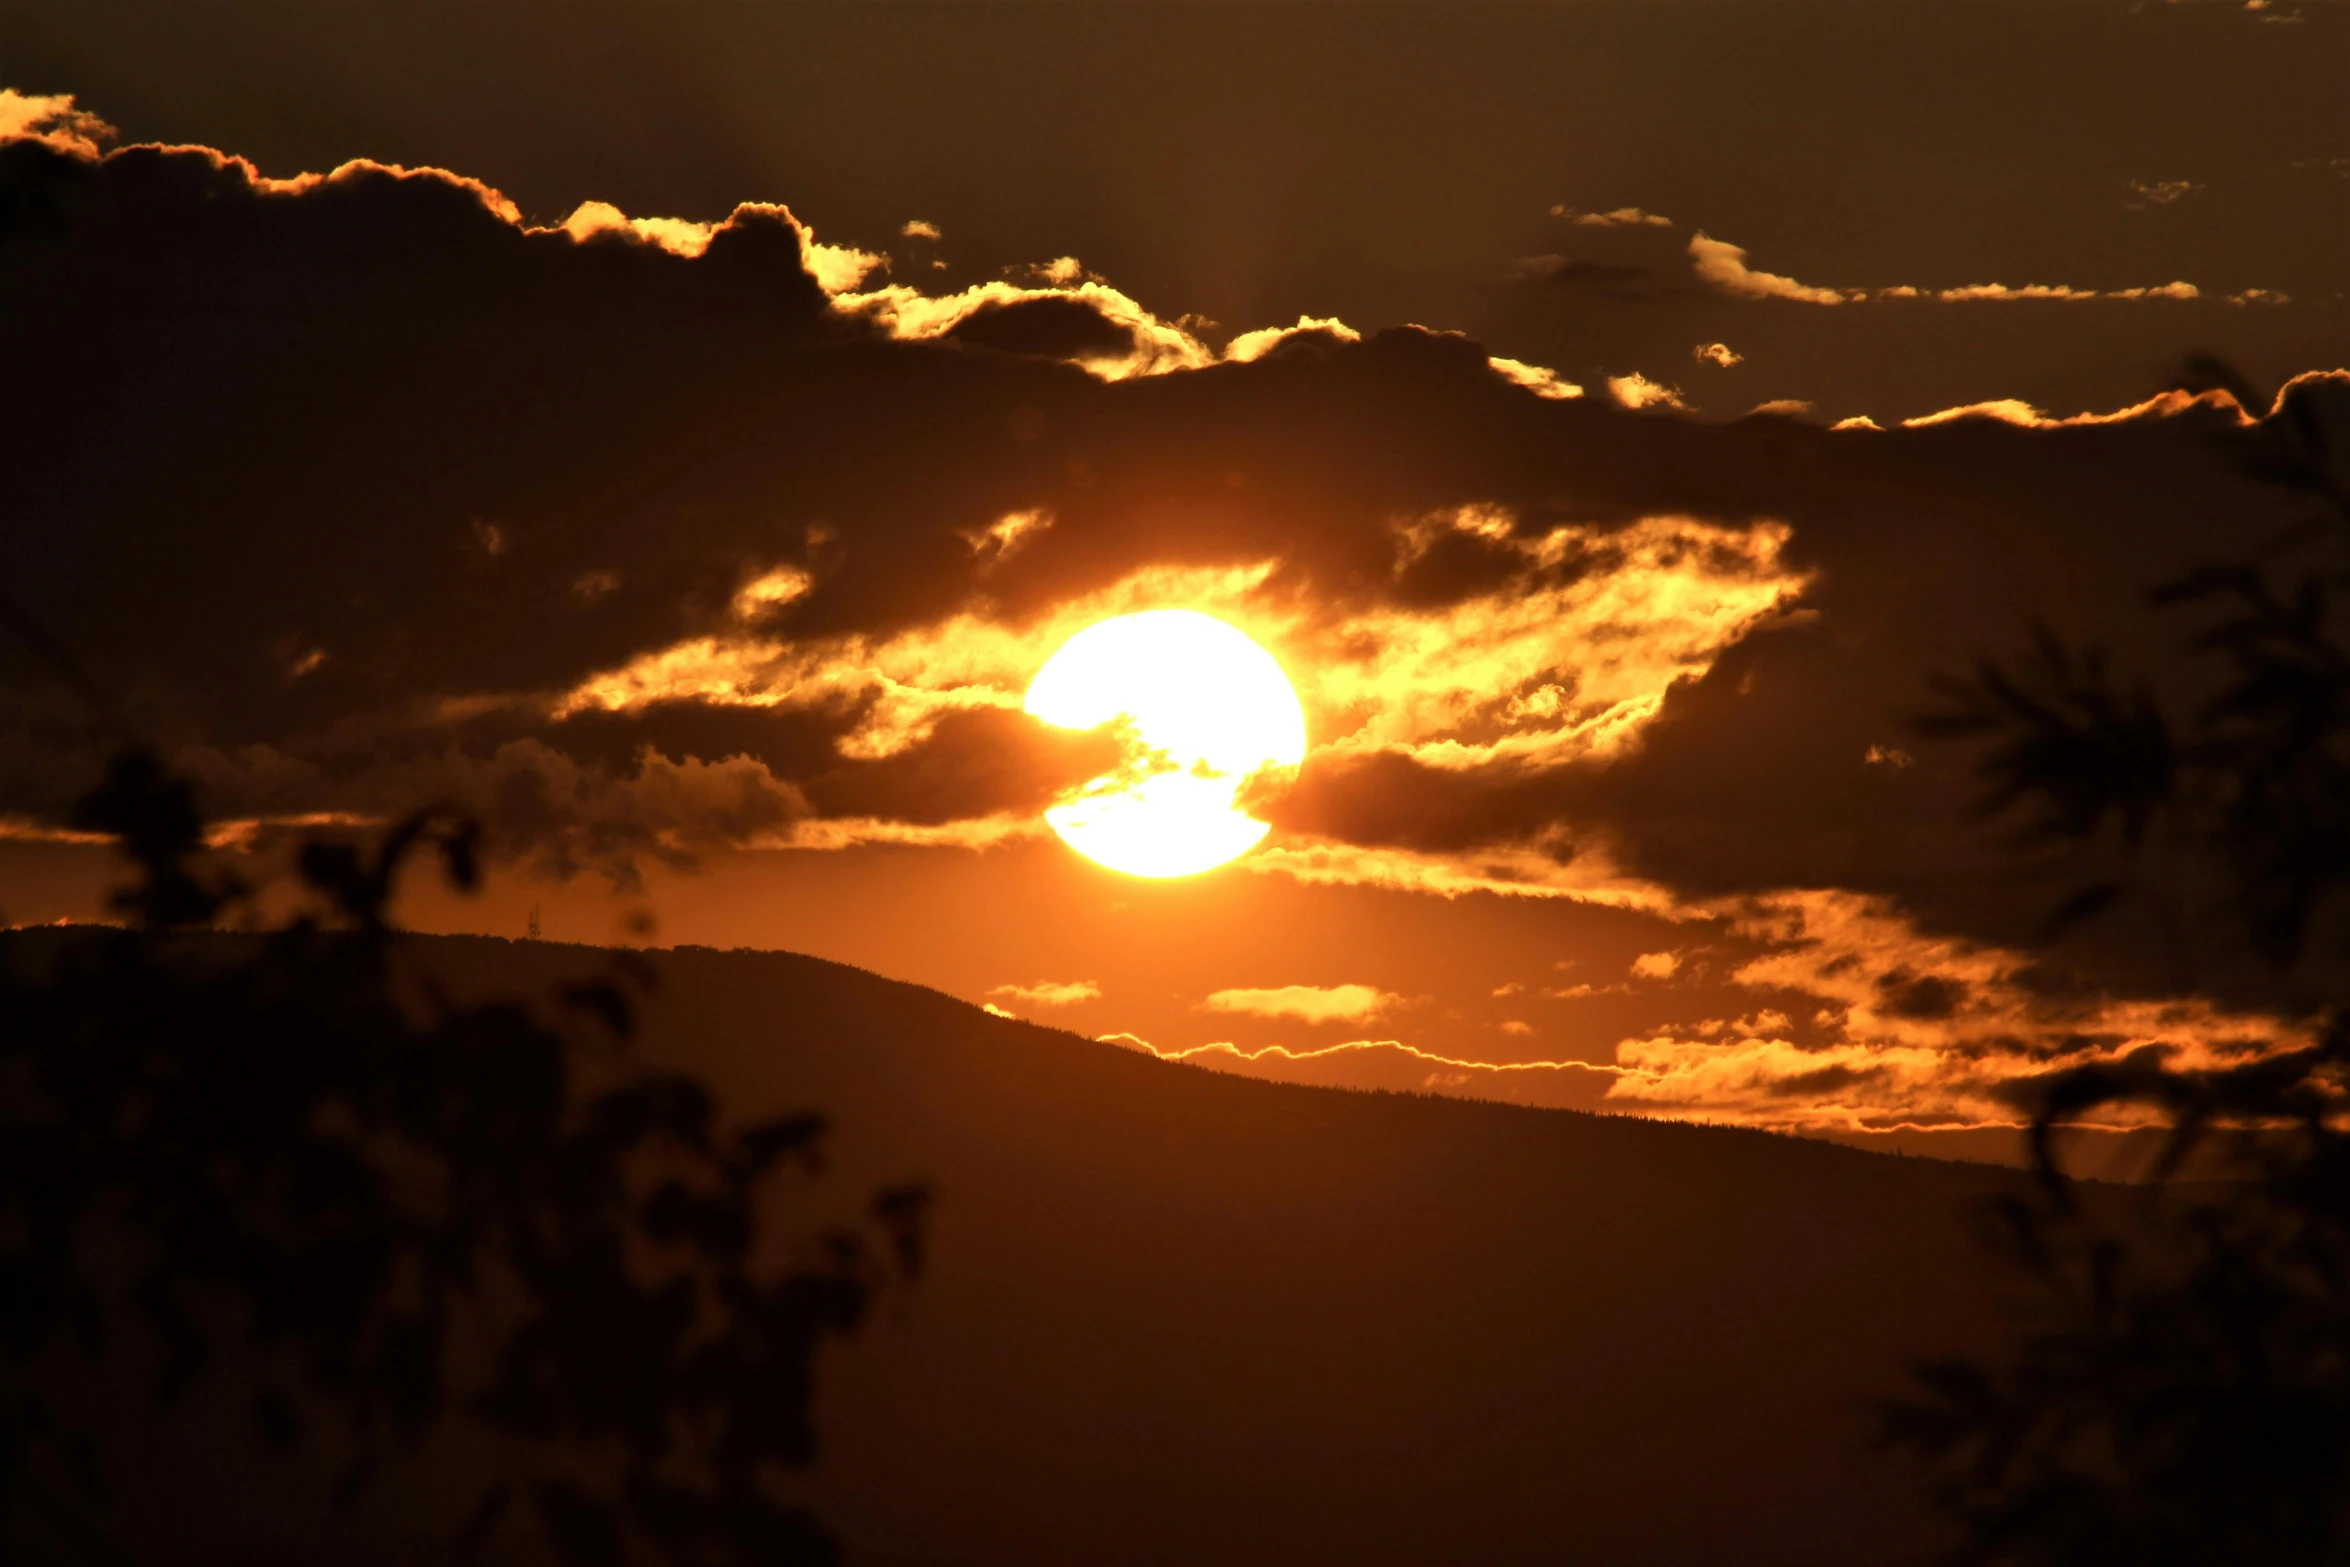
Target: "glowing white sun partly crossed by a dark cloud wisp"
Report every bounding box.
[1027,608,1307,876]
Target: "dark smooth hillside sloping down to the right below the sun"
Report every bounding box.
[45,937,2000,1567]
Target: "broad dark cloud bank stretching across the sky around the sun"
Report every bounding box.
[0,119,2343,1006]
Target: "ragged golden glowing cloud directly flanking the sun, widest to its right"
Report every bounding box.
[557,491,1800,864]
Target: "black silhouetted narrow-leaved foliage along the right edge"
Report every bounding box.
[1885,364,2350,1567]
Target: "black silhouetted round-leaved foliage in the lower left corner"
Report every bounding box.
[0,749,924,1565]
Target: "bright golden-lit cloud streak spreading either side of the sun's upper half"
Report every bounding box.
[548,507,1805,864]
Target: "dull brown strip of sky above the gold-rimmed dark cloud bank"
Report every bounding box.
[13,0,2350,423]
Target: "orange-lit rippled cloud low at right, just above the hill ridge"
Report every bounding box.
[1114,890,2305,1135]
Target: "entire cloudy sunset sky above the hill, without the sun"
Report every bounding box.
[0,0,2350,1151]
